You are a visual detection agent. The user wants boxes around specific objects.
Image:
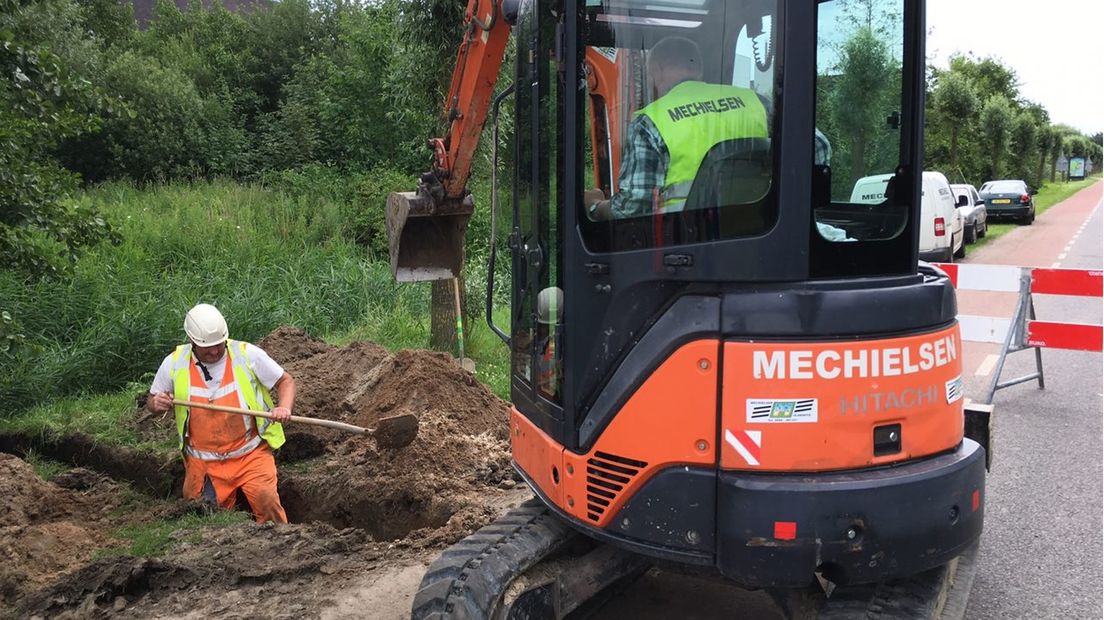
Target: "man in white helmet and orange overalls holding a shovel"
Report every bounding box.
[146,303,295,523]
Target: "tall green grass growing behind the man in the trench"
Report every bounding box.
[0,182,439,417]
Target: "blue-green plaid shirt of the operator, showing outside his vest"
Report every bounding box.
[609,109,831,220]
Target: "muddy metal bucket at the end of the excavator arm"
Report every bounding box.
[386,188,473,282]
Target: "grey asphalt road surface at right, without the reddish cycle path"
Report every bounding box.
[966,190,1104,619]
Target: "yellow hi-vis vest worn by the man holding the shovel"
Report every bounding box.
[170,340,285,460]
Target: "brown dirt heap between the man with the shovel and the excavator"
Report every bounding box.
[259,328,513,546]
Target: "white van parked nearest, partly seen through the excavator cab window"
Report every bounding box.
[851,172,966,263]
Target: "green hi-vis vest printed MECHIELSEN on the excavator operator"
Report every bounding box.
[637,82,769,213]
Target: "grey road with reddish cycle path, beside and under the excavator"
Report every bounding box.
[594,183,1104,620]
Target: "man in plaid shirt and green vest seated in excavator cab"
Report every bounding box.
[585,36,769,220]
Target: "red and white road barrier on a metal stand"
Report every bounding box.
[934,263,1104,406]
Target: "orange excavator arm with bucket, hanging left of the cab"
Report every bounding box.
[386,0,518,281]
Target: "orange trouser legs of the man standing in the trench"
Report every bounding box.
[184,443,287,523]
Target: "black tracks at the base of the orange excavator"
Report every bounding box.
[411,498,977,620]
